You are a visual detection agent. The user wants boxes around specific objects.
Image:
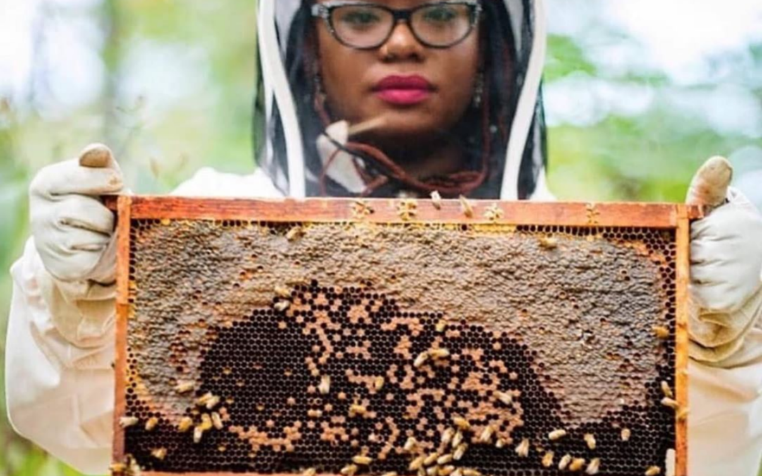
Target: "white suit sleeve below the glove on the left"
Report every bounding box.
[5,239,114,474]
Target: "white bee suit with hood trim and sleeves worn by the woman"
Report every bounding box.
[6,0,762,476]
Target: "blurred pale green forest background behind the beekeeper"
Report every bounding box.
[0,0,762,476]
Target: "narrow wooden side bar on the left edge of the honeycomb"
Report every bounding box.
[112,196,132,462]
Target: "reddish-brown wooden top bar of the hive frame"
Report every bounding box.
[107,196,703,228]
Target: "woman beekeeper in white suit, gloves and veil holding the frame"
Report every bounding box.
[6,0,762,476]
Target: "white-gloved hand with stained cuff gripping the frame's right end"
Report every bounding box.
[687,157,762,363]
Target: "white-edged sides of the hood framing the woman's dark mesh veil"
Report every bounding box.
[255,0,546,200]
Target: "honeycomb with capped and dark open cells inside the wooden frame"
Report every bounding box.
[120,219,676,476]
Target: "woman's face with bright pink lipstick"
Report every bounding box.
[315,0,479,149]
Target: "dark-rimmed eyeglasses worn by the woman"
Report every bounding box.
[312,0,482,50]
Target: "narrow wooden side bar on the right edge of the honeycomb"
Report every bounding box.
[675,206,690,476]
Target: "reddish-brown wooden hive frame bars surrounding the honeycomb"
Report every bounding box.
[107,196,703,476]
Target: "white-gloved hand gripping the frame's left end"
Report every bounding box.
[30,144,123,284]
